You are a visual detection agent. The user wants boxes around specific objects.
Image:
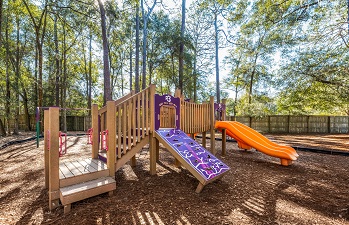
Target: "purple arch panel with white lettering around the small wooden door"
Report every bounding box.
[154,94,181,130]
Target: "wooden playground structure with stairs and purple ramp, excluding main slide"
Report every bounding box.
[44,85,298,213]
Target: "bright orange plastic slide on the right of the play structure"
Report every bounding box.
[215,121,299,166]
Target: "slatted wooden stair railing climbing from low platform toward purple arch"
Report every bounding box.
[96,88,151,171]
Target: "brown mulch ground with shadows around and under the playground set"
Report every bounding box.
[0,135,349,224]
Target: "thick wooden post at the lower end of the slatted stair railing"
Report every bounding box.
[107,101,115,177]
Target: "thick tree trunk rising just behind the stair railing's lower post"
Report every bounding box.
[98,0,112,105]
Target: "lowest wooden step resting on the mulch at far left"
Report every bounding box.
[60,177,116,213]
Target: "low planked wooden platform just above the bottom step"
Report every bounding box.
[59,159,109,188]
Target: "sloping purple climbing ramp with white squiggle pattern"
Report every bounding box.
[156,129,230,181]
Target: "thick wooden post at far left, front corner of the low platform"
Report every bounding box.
[48,107,59,210]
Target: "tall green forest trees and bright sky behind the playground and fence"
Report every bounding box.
[0,0,349,133]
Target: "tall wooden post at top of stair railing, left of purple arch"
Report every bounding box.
[149,84,157,175]
